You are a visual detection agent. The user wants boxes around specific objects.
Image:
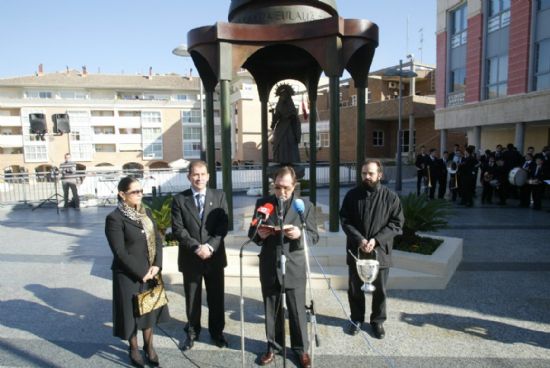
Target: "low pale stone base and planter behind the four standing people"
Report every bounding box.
[163,230,462,290]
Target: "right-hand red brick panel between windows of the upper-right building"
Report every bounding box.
[508,0,531,95]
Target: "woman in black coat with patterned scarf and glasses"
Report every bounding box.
[105,176,169,367]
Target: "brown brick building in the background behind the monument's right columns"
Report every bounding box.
[310,59,465,162]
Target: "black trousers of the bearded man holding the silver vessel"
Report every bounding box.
[348,263,390,323]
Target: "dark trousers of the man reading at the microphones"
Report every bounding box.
[262,280,309,354]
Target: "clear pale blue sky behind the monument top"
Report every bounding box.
[0,0,436,78]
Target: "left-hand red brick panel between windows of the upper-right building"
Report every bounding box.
[465,14,483,103]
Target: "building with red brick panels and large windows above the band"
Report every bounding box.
[435,0,550,152]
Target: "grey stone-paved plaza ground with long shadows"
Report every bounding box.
[0,183,550,368]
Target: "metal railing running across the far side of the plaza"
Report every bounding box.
[0,163,355,206]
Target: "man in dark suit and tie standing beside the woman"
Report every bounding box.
[172,161,228,349]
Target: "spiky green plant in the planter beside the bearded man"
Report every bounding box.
[394,193,452,254]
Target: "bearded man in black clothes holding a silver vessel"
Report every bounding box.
[340,160,405,339]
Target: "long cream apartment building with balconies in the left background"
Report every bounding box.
[0,66,219,172]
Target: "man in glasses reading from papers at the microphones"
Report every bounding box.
[248,166,319,368]
